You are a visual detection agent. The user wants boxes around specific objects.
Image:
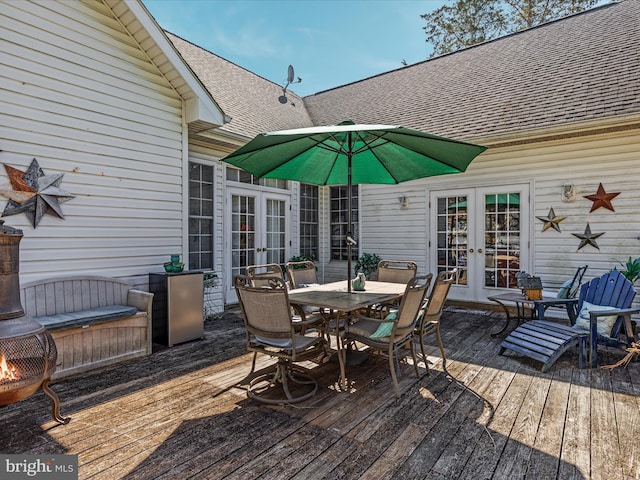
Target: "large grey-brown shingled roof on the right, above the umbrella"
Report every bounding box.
[304,0,640,139]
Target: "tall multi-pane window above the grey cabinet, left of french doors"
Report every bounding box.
[189,162,213,270]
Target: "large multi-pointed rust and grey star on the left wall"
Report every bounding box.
[0,158,73,228]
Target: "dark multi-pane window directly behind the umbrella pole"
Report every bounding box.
[330,185,359,260]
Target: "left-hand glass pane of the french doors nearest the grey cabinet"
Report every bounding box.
[231,195,256,275]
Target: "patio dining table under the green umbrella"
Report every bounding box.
[289,280,406,388]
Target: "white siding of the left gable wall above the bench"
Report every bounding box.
[0,1,183,284]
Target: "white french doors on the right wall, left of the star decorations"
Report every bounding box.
[430,184,530,301]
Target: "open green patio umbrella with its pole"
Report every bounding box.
[222,121,487,291]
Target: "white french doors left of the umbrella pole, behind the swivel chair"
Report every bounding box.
[225,189,290,302]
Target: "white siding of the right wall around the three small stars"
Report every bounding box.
[327,131,640,287]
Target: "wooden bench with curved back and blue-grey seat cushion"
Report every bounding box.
[20,276,153,379]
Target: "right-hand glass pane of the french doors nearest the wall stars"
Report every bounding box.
[484,193,520,288]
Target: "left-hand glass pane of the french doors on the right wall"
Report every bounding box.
[436,196,468,285]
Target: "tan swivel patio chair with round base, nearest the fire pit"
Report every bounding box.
[233,275,327,405]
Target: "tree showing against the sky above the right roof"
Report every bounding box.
[420,0,598,57]
